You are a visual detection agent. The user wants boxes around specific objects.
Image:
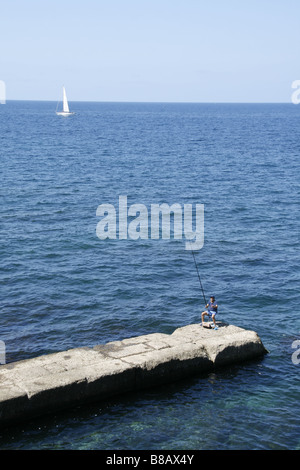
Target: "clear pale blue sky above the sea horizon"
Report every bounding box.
[0,0,300,102]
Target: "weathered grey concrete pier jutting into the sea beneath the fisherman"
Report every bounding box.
[0,324,267,426]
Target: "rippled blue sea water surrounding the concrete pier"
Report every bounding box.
[0,101,300,450]
